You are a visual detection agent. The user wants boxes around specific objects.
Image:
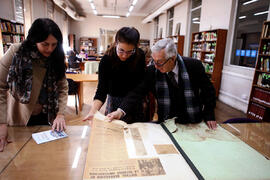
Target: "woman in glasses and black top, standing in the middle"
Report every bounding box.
[85,27,145,124]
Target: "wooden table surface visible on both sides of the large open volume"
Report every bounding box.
[0,123,270,180]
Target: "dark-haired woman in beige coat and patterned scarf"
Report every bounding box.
[0,18,68,151]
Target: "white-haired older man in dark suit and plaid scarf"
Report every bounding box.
[107,38,217,129]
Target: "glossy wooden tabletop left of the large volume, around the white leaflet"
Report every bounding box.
[0,126,90,180]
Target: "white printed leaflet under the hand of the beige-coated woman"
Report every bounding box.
[32,130,68,144]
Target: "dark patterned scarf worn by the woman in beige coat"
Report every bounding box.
[7,48,59,124]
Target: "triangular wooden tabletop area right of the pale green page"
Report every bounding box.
[221,123,270,159]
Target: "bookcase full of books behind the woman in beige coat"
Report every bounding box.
[0,19,24,58]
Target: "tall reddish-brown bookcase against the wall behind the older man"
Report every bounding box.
[190,29,227,97]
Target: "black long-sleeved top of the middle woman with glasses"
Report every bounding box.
[94,49,145,103]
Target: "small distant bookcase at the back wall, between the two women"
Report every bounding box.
[80,37,97,56]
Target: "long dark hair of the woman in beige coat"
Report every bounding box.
[18,18,65,80]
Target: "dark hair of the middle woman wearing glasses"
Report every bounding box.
[105,27,143,69]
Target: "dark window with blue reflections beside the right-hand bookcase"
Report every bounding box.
[231,0,269,68]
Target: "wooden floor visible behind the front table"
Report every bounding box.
[65,82,246,125]
